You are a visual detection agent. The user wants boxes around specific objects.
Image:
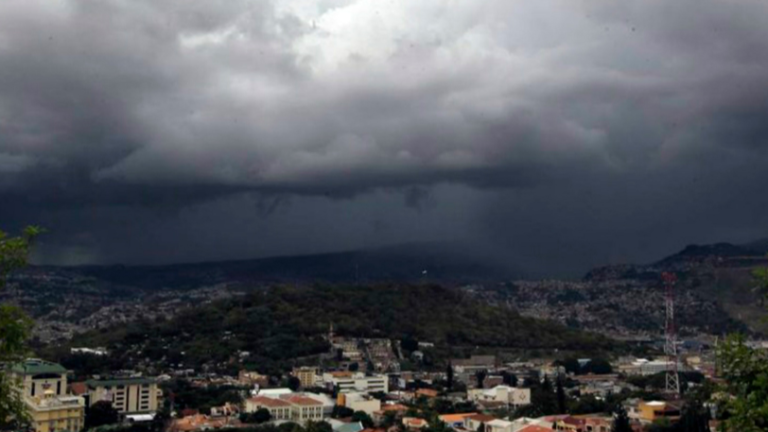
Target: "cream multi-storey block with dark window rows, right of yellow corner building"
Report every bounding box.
[85,377,163,416]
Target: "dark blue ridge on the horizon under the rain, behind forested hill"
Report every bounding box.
[51,243,515,289]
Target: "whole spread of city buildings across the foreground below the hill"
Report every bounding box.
[11,343,720,432]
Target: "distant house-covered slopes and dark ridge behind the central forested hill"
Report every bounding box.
[2,236,768,342]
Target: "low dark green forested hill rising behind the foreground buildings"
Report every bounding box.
[64,285,612,372]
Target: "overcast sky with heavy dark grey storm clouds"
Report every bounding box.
[0,0,768,273]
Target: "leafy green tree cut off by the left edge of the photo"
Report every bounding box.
[0,227,42,424]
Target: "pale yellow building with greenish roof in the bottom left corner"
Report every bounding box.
[12,359,85,432]
